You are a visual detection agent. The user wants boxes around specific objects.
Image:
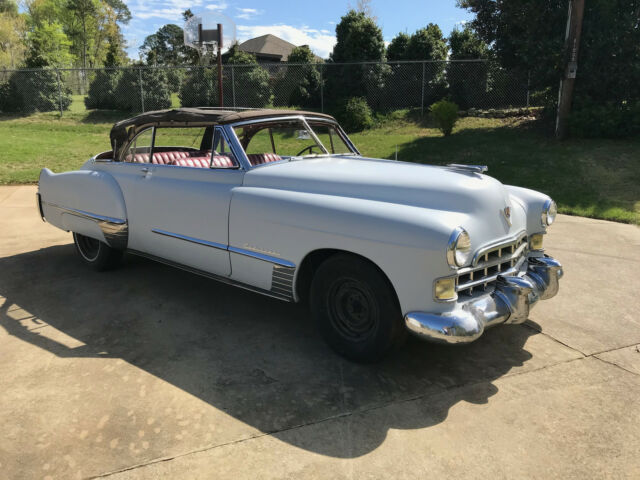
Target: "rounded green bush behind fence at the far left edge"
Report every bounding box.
[0,69,71,113]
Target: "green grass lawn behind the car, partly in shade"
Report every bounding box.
[0,111,640,224]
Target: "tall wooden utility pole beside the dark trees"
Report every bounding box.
[556,0,584,139]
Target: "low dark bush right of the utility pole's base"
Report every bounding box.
[568,102,640,138]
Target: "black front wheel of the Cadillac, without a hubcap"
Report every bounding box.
[310,255,406,362]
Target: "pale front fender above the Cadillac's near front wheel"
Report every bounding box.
[229,187,466,312]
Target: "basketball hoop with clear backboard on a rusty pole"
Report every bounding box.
[183,12,236,107]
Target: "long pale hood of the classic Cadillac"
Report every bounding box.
[243,155,526,243]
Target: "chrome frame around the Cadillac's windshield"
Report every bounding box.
[225,115,360,170]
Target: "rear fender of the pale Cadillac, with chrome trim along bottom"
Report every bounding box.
[38,168,128,249]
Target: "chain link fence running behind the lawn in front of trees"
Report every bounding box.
[0,60,533,115]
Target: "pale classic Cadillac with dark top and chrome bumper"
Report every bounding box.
[37,108,563,361]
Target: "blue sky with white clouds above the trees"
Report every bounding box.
[123,0,471,59]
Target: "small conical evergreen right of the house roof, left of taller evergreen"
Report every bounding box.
[275,45,321,108]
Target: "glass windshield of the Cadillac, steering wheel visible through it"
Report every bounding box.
[234,118,355,163]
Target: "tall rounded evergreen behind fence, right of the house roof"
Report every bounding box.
[327,10,388,109]
